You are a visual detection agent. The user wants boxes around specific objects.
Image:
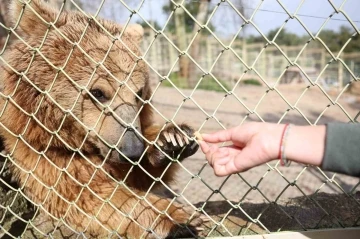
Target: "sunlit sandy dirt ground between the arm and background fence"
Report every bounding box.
[153,82,360,132]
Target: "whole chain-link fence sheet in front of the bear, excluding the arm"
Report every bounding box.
[0,0,360,238]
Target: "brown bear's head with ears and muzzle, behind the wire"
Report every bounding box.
[0,0,151,162]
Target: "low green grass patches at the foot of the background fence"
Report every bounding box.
[161,73,231,92]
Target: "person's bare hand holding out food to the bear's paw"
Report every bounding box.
[199,123,285,176]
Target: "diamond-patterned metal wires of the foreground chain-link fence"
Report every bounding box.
[0,0,360,238]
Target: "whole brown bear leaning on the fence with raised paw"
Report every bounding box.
[0,0,203,238]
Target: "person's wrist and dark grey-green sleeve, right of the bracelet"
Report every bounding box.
[277,123,360,176]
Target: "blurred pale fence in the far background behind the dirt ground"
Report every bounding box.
[145,32,360,91]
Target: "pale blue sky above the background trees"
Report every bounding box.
[88,0,360,37]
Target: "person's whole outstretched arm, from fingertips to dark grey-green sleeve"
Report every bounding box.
[200,122,360,176]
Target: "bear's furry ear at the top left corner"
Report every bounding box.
[9,0,58,36]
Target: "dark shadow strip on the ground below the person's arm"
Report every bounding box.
[196,192,360,237]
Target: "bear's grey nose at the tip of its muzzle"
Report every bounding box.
[120,128,145,161]
